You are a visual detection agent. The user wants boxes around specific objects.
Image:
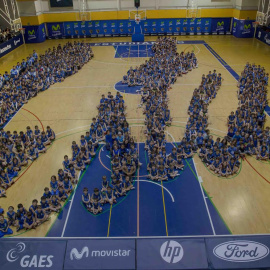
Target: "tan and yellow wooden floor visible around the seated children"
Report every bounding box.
[0,36,270,236]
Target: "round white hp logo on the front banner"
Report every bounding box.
[160,240,184,263]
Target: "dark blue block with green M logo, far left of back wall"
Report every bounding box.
[24,24,46,43]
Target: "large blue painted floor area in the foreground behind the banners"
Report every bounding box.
[47,144,230,237]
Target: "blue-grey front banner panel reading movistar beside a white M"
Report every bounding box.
[64,240,135,270]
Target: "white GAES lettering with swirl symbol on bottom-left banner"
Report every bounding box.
[6,242,54,268]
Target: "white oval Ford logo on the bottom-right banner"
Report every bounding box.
[213,240,269,262]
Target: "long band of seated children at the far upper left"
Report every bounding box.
[0,41,93,127]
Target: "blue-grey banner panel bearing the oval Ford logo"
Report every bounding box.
[205,236,270,269]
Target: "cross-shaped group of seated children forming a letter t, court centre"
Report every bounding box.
[122,37,198,181]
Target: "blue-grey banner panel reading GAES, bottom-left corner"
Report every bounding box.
[0,240,66,270]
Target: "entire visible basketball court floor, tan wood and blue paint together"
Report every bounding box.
[0,1,270,245]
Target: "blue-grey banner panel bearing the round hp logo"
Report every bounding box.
[137,238,208,269]
